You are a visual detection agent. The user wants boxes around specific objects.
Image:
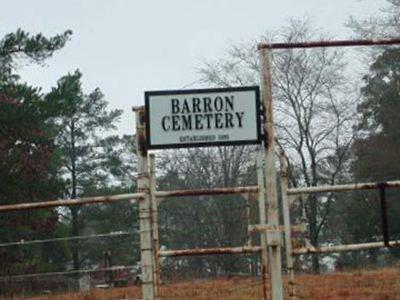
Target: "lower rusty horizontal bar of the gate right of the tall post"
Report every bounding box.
[293,240,400,255]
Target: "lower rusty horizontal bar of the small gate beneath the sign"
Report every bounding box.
[158,246,261,257]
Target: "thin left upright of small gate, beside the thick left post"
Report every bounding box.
[149,153,160,299]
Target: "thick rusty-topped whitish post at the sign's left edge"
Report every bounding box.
[135,108,155,300]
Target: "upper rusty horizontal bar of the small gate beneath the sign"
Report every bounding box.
[156,186,258,198]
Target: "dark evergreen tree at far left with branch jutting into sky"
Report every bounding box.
[0,30,71,274]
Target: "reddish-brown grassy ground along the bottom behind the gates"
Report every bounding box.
[14,268,400,300]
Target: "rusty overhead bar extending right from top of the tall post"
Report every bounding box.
[258,39,400,50]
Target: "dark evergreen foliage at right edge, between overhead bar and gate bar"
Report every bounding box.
[354,49,400,181]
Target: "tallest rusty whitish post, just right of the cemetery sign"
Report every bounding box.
[260,48,283,300]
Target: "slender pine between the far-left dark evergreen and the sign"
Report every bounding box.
[46,70,136,269]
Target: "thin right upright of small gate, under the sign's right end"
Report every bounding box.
[257,148,268,300]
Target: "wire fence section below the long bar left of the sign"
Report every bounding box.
[0,203,141,299]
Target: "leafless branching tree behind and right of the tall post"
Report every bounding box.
[199,19,355,271]
